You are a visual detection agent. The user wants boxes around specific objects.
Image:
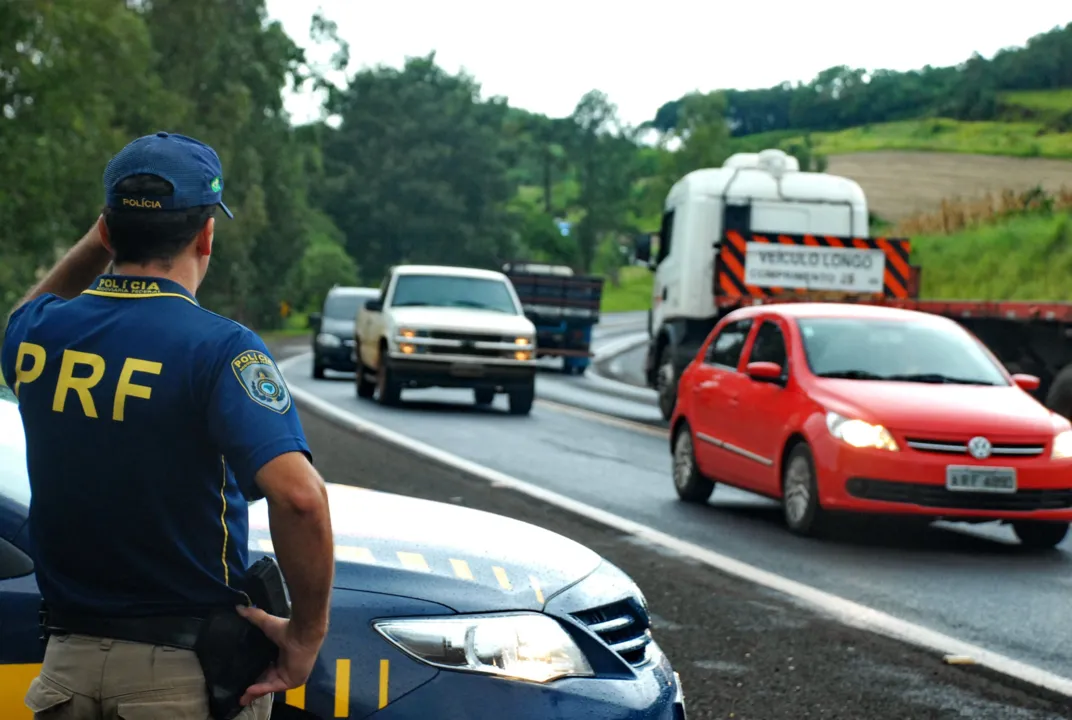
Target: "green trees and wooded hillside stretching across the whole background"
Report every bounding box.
[0,0,1072,325]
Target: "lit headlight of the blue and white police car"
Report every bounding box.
[373,613,594,683]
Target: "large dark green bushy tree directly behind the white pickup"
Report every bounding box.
[322,54,516,274]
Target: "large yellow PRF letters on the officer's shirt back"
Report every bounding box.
[13,342,164,422]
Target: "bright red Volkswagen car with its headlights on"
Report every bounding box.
[670,303,1072,548]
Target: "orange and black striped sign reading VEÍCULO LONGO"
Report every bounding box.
[715,230,911,298]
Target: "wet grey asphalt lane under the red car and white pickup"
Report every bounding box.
[282,327,1072,677]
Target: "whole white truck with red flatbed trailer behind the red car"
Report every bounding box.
[636,149,1072,419]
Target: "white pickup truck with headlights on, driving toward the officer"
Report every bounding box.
[354,265,536,415]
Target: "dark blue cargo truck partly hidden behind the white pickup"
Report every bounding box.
[503,261,604,375]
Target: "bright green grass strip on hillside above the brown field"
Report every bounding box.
[734,117,1072,158]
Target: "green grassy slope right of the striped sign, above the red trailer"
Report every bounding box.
[912,213,1072,301]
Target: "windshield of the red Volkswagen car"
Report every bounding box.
[796,317,1009,385]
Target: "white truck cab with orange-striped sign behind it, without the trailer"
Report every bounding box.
[637,150,870,419]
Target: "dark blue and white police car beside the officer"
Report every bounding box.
[0,387,685,720]
